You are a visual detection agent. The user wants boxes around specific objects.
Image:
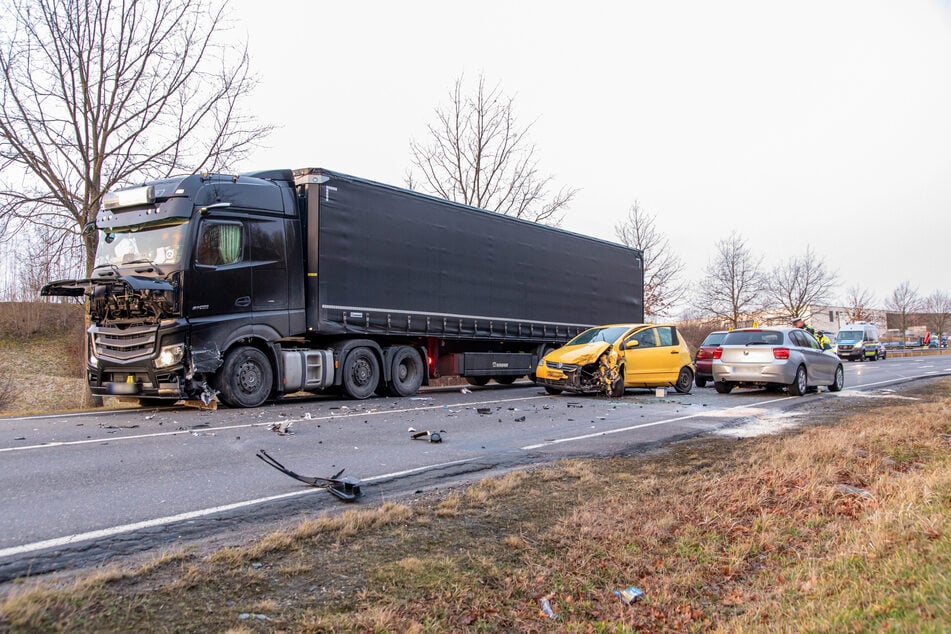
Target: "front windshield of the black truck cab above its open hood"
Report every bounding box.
[96,223,187,266]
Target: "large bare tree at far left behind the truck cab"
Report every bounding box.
[0,0,269,273]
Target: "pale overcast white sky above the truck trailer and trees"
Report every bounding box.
[231,0,951,312]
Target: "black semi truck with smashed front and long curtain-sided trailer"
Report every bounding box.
[42,168,644,407]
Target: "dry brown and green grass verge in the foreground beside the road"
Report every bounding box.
[0,380,951,632]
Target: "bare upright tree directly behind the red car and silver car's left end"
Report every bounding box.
[694,231,766,328]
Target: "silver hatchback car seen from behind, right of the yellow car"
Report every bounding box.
[713,327,845,396]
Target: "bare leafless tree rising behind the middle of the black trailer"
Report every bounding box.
[406,75,578,225]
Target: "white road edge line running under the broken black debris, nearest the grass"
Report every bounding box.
[0,458,475,559]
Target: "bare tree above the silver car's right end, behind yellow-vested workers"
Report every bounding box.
[767,247,838,318]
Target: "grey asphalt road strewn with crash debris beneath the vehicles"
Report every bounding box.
[0,356,951,581]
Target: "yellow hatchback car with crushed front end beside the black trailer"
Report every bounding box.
[535,324,694,397]
